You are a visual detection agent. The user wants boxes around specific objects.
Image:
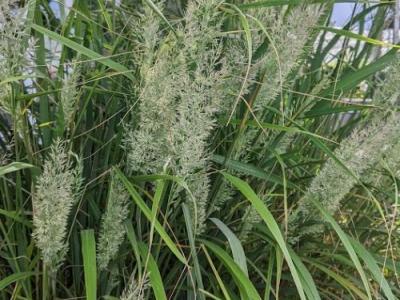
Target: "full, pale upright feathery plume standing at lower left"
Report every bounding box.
[33,140,82,271]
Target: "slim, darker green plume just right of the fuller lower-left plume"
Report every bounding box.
[97,178,129,270]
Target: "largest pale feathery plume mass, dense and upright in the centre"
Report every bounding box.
[125,0,238,231]
